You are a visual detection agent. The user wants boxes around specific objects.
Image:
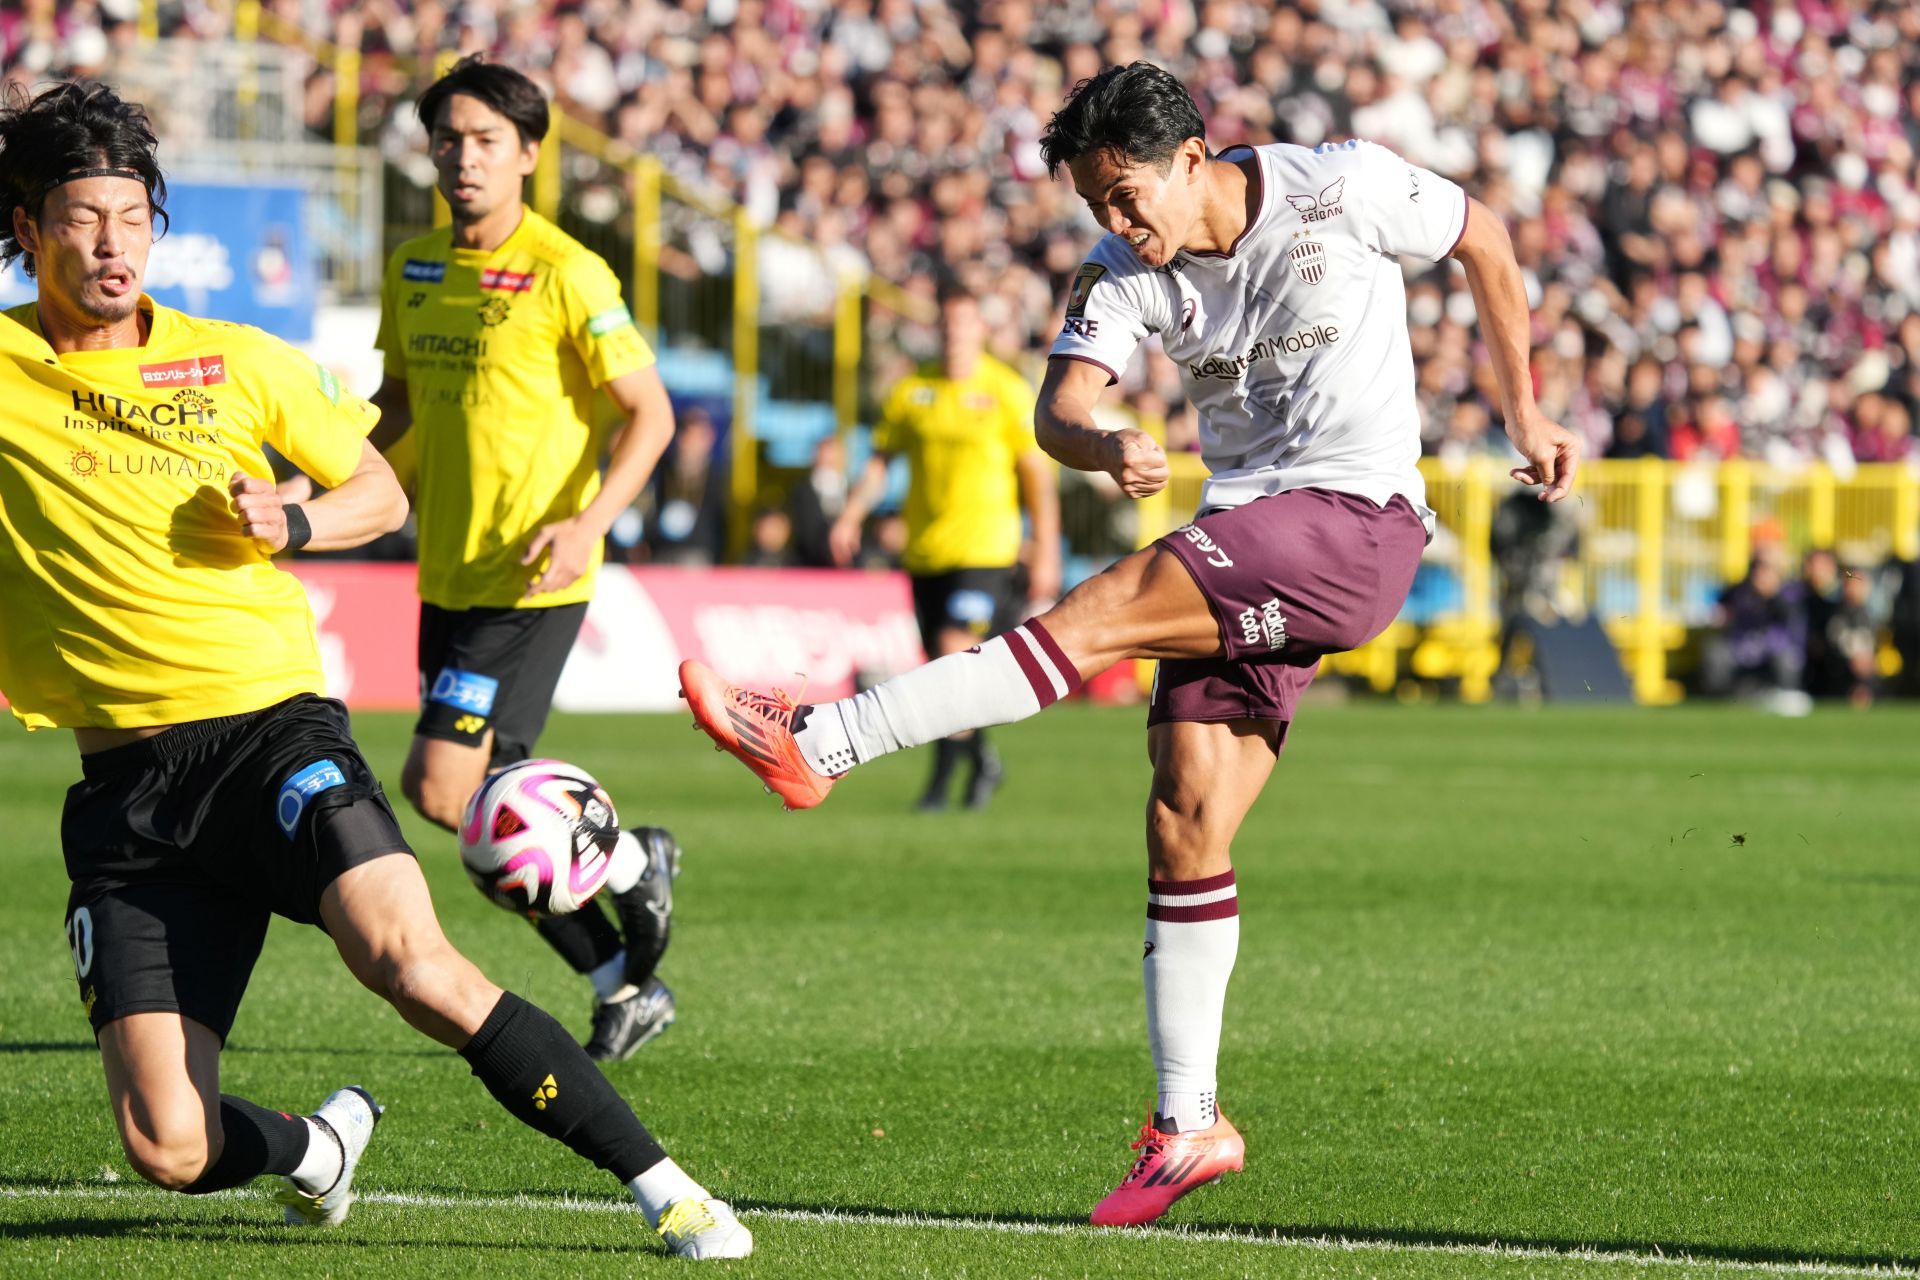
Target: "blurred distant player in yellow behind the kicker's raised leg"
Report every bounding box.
[831,290,1060,812]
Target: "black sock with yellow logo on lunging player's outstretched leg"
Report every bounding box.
[461,990,666,1182]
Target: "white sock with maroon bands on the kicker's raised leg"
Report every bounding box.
[793,618,1081,777]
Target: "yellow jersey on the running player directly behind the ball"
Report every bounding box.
[380,209,653,608]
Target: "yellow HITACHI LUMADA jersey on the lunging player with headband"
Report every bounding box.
[0,296,380,729]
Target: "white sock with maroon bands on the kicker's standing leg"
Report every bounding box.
[1140,871,1240,1132]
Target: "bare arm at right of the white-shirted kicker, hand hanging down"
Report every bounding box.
[1453,200,1580,503]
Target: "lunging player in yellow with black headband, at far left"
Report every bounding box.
[0,84,751,1257]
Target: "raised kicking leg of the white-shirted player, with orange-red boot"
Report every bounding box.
[680,545,1221,810]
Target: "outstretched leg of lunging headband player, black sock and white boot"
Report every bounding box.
[321,854,753,1257]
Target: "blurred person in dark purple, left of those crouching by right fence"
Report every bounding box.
[1701,543,1809,714]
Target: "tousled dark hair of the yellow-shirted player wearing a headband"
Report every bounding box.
[0,83,167,278]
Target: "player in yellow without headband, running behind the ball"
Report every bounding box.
[374,58,680,1059]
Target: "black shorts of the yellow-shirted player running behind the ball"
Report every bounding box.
[413,603,588,766]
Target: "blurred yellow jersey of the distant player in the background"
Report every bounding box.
[874,355,1039,574]
